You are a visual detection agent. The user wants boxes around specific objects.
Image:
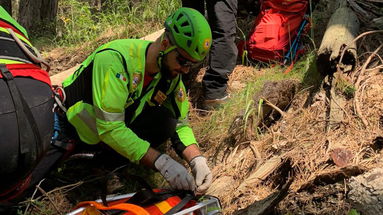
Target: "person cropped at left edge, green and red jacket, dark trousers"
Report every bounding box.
[0,6,54,209]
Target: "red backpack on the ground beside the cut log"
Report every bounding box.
[242,0,308,63]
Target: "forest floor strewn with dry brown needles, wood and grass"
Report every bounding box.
[20,0,383,215]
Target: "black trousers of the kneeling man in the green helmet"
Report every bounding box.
[32,106,177,171]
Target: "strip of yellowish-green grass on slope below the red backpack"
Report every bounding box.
[193,51,316,148]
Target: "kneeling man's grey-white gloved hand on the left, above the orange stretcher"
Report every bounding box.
[154,154,195,191]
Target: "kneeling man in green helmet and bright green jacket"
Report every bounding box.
[63,8,212,193]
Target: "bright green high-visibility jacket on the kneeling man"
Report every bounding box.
[63,39,196,163]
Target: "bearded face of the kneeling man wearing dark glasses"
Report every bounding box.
[161,48,199,80]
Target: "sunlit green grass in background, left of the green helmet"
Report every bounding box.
[50,0,180,46]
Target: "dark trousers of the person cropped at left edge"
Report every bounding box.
[0,77,53,201]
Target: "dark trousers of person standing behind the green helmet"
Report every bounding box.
[182,0,238,99]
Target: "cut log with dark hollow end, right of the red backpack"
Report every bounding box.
[317,1,359,74]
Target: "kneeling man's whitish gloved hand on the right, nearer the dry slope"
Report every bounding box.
[190,156,213,194]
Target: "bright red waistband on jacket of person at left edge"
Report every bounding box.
[0,64,51,86]
